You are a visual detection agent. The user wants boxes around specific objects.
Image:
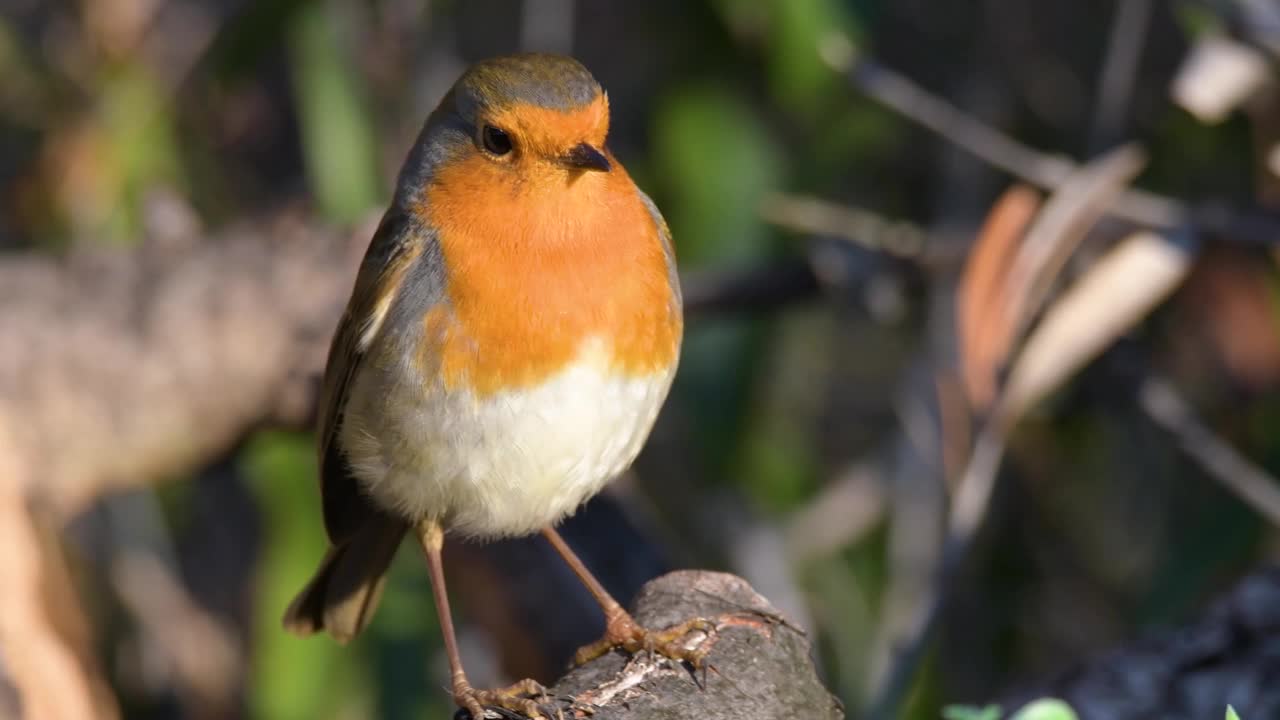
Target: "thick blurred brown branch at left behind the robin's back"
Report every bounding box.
[0,207,370,518]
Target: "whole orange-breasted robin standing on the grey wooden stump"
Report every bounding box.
[284,54,714,720]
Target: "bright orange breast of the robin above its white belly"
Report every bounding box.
[419,155,681,396]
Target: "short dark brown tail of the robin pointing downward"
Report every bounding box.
[284,518,408,643]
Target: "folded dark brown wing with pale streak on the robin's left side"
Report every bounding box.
[317,208,428,544]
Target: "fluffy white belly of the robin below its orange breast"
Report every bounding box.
[340,338,673,537]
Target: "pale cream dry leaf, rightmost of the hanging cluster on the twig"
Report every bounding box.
[1001,232,1192,427]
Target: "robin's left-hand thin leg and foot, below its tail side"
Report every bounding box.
[415,520,548,720]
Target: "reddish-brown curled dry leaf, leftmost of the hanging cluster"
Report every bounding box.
[956,184,1041,410]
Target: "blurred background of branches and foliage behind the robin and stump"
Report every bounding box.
[0,0,1280,720]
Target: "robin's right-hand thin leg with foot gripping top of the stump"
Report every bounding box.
[543,528,716,667]
